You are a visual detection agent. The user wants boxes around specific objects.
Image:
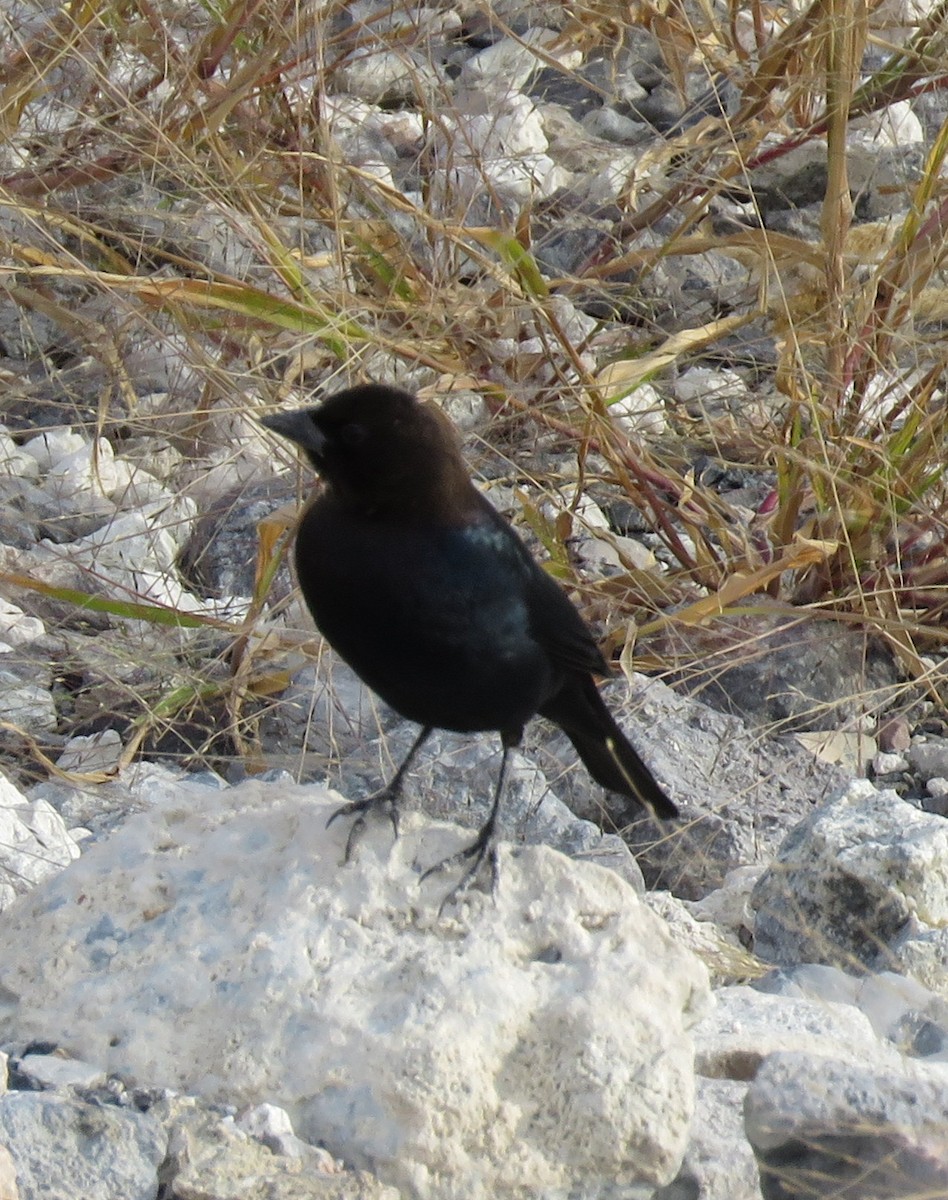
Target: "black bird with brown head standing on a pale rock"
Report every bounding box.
[259,383,678,898]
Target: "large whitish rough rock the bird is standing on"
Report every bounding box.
[0,782,708,1200]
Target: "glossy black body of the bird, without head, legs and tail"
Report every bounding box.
[296,497,580,733]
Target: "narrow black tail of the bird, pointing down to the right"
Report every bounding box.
[540,677,678,820]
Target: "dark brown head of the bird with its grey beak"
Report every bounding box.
[260,384,470,511]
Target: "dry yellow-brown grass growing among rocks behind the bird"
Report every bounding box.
[0,0,948,768]
